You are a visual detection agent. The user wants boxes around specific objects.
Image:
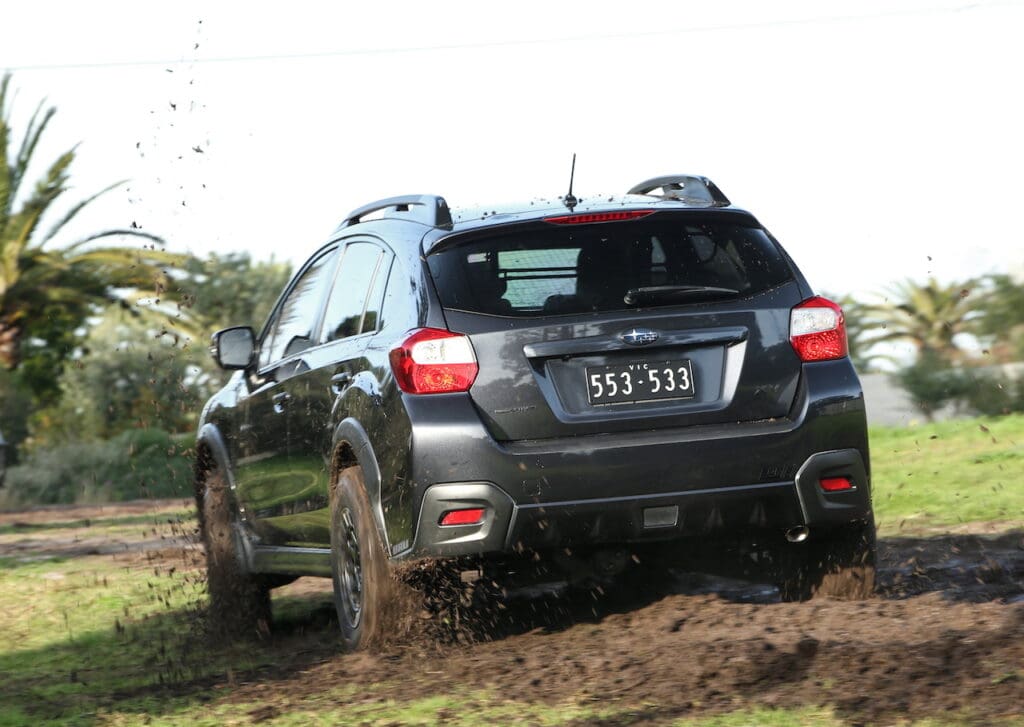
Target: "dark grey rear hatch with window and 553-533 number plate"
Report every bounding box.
[427,210,802,441]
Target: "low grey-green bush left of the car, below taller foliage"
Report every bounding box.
[6,429,194,505]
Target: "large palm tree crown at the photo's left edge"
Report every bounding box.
[0,74,181,370]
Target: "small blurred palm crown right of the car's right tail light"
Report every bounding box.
[866,279,979,360]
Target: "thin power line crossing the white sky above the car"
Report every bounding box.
[5,0,1019,72]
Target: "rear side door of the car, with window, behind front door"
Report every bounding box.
[282,239,390,547]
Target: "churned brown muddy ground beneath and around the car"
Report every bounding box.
[0,504,1024,724]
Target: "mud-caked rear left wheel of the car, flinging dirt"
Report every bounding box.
[331,467,391,651]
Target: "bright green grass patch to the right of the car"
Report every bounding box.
[870,415,1024,534]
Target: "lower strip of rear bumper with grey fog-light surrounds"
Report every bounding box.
[413,450,870,557]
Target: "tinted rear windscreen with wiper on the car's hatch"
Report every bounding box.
[427,215,793,316]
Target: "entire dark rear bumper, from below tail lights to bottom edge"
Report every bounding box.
[393,361,870,557]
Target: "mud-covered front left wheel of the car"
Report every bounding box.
[196,467,270,637]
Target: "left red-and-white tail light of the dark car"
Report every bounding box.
[390,328,479,394]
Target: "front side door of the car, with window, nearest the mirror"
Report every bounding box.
[236,248,337,545]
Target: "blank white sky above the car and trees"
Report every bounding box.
[0,0,1024,293]
